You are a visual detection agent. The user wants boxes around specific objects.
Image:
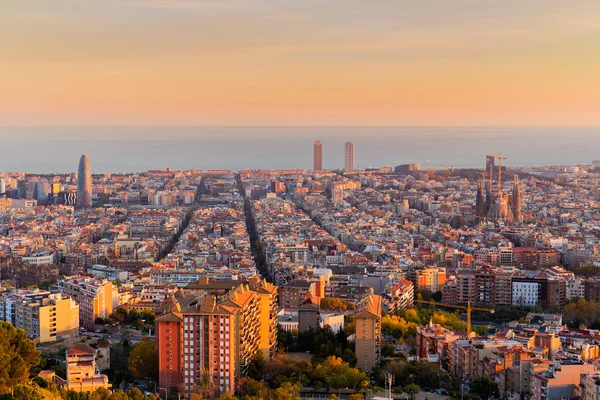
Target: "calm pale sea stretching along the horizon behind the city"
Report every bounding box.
[0,127,600,173]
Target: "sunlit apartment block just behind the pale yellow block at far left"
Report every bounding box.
[56,276,118,329]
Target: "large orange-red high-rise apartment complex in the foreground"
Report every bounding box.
[156,279,277,397]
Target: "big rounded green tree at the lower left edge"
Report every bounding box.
[0,322,40,393]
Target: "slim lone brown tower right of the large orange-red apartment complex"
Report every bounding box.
[354,289,381,371]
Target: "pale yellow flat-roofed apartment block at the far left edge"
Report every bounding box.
[0,289,79,343]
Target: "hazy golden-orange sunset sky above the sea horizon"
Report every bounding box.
[0,0,600,125]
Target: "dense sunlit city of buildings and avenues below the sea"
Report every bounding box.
[0,140,600,400]
